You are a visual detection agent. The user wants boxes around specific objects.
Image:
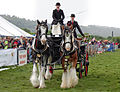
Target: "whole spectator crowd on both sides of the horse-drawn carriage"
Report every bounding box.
[0,36,120,62]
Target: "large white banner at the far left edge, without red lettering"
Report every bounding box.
[0,49,17,67]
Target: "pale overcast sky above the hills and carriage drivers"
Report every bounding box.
[0,0,120,28]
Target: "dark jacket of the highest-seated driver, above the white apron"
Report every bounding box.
[52,9,65,25]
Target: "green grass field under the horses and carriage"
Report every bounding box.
[0,50,120,92]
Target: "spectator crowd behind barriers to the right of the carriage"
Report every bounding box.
[88,38,120,56]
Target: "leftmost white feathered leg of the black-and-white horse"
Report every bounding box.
[30,62,39,88]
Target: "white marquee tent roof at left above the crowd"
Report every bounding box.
[0,16,33,37]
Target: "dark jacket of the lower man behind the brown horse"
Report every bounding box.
[67,21,84,38]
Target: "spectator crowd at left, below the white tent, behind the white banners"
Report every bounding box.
[0,36,33,62]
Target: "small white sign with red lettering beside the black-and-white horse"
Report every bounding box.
[18,50,27,65]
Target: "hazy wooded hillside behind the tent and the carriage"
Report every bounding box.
[1,15,120,37]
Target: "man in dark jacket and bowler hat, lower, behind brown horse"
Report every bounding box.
[67,14,85,38]
